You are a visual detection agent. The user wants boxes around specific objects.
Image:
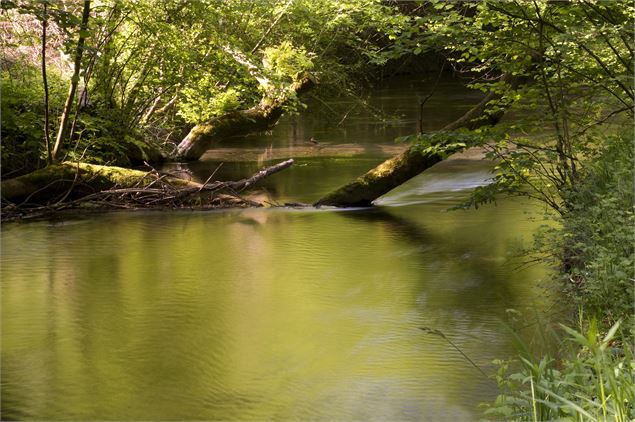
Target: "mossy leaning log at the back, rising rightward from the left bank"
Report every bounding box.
[172,73,316,161]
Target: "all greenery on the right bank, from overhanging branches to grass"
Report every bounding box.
[414,2,635,421]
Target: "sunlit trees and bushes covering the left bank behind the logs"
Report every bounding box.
[1,0,398,174]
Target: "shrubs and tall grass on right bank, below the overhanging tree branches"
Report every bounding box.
[484,135,635,422]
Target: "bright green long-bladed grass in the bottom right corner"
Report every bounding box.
[485,321,635,422]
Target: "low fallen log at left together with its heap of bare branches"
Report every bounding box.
[1,159,293,220]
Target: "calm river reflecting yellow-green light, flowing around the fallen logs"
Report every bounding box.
[1,77,549,421]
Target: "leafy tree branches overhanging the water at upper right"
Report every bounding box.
[384,0,635,213]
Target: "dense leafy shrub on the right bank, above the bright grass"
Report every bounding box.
[561,135,635,322]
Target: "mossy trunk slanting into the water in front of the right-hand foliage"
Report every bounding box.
[314,74,520,207]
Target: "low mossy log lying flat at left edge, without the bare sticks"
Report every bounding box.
[0,162,192,204]
